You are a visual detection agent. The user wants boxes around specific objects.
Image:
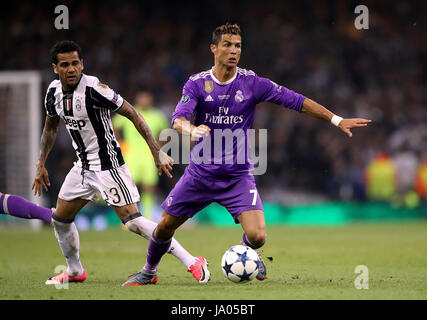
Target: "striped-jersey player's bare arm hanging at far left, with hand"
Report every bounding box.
[31,117,59,196]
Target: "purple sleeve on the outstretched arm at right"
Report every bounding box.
[255,76,305,112]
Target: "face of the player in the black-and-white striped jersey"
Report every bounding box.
[53,51,83,90]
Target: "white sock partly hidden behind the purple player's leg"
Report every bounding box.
[126,216,196,268]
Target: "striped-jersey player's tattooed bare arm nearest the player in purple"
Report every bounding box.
[117,100,173,178]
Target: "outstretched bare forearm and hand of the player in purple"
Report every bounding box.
[301,98,371,138]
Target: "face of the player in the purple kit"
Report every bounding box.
[211,34,242,68]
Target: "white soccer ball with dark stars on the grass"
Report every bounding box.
[221,245,260,283]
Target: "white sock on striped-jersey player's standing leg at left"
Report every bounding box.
[52,214,83,276]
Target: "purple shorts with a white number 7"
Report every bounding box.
[162,166,264,223]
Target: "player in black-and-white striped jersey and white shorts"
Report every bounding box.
[32,41,209,284]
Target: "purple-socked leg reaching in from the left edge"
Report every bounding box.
[0,194,52,223]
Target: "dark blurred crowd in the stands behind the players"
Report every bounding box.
[0,0,427,208]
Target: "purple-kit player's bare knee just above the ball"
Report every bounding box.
[237,210,266,245]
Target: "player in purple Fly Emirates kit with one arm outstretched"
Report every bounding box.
[124,23,371,285]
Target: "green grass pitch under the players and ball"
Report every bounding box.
[0,222,427,300]
